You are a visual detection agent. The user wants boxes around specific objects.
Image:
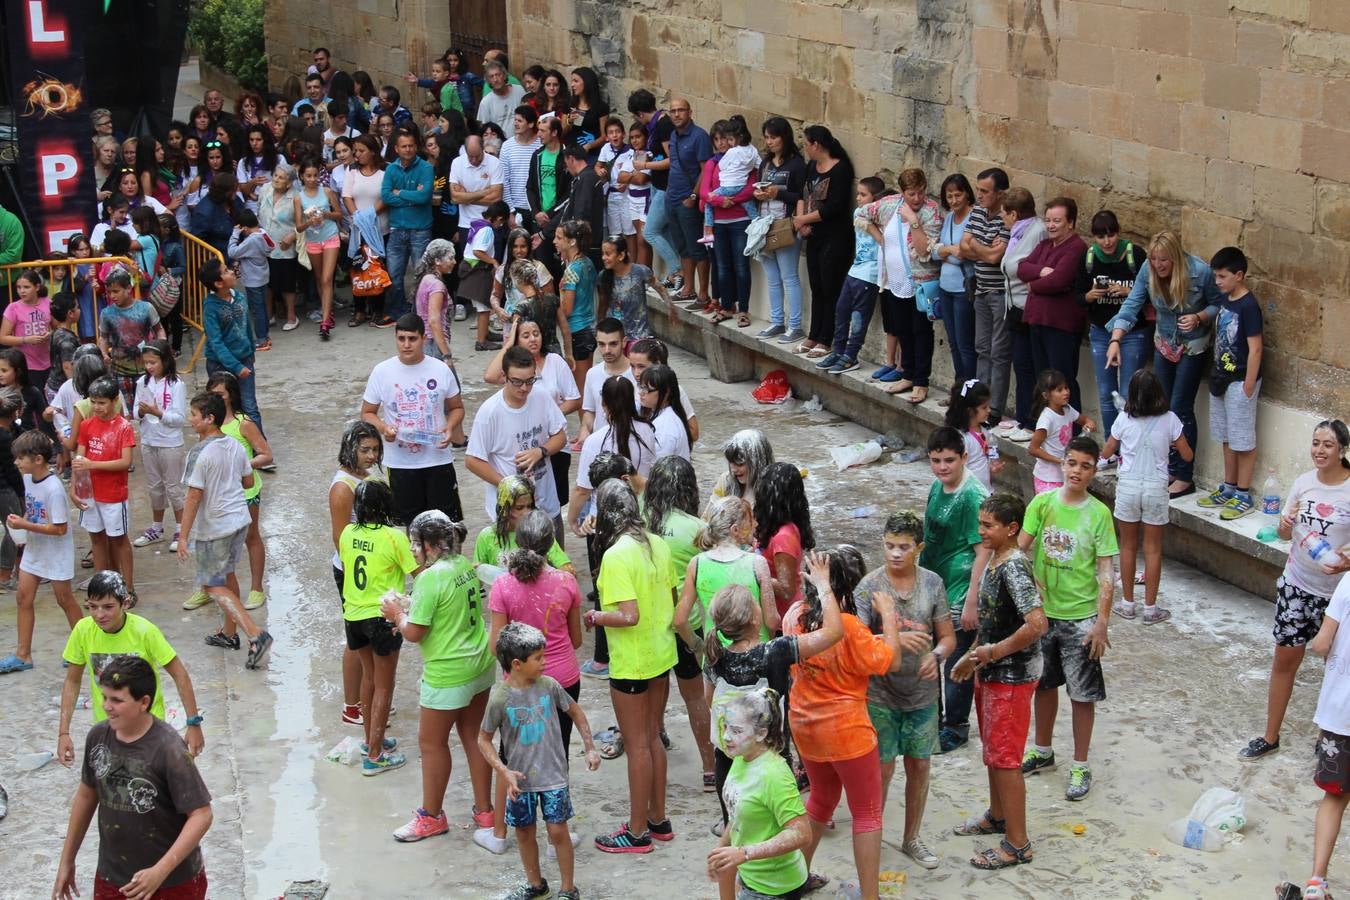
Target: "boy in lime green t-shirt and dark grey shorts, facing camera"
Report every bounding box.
[1018,434,1119,800]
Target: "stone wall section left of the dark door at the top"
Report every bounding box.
[263,0,451,101]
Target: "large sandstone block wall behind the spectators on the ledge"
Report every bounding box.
[508,0,1350,416]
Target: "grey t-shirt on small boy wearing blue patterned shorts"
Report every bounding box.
[482,675,572,791]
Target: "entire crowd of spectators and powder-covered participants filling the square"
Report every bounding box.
[0,42,1350,900]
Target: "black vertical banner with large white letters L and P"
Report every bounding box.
[5,0,96,254]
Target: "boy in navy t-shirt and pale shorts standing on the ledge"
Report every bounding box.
[1196,247,1265,522]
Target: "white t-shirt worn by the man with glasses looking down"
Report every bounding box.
[467,390,567,521]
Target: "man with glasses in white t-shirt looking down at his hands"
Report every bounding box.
[464,347,567,530]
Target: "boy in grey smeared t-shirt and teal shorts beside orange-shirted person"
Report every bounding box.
[853,511,956,869]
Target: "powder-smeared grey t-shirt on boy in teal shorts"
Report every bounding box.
[853,565,952,710]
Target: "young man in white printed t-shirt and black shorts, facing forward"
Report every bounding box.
[360,313,464,524]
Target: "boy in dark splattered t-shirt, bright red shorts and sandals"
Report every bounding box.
[952,494,1048,869]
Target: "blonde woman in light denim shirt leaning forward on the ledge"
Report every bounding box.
[1106,231,1223,498]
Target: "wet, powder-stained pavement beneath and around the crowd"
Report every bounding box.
[0,310,1322,900]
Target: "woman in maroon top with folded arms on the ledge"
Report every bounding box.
[1017,197,1088,409]
